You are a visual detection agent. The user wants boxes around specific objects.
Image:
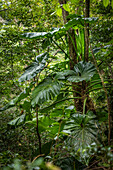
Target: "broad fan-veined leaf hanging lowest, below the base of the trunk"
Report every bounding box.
[65,113,97,151]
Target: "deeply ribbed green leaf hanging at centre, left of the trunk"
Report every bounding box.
[31,78,61,106]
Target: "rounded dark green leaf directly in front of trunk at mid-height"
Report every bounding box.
[67,61,96,82]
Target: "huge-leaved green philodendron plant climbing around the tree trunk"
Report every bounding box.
[0,15,110,165]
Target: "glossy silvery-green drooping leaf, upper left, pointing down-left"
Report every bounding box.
[19,52,49,82]
